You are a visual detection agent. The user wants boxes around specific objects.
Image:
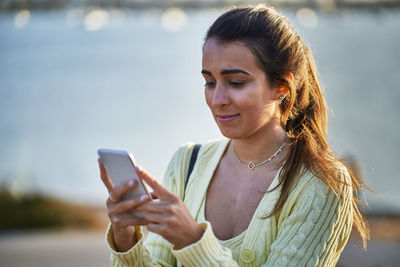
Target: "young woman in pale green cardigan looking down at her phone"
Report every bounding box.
[100,5,368,267]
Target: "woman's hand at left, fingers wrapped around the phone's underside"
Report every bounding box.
[98,159,152,252]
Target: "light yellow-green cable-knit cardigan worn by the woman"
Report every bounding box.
[106,139,353,267]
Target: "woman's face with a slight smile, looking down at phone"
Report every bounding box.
[202,38,280,139]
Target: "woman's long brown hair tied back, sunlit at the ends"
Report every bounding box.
[203,5,369,247]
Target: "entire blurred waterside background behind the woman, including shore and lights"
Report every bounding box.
[0,0,400,266]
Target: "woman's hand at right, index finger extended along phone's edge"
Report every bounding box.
[135,167,204,249]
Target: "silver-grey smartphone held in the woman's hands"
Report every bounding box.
[97,148,152,208]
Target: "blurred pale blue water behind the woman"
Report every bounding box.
[0,10,400,211]
